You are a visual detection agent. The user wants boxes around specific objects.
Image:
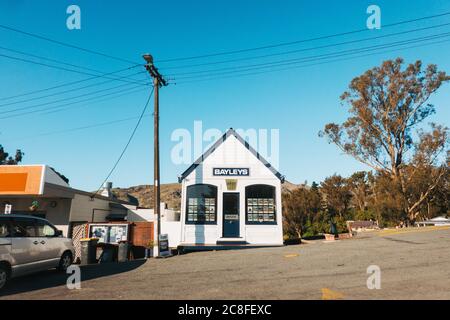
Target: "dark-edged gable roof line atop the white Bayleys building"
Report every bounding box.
[178,128,285,183]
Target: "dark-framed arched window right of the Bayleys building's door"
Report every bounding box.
[245,184,277,224]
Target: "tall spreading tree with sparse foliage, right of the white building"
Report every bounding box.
[319,58,450,221]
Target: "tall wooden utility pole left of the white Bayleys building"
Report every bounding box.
[143,54,167,256]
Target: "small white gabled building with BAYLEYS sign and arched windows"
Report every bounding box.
[179,129,284,246]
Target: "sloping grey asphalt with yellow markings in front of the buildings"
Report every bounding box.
[0,227,450,299]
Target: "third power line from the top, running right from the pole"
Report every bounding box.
[171,32,450,79]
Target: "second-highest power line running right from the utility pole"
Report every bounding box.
[164,23,450,71]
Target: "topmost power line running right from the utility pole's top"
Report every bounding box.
[158,12,450,62]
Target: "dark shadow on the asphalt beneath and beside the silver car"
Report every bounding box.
[0,259,146,298]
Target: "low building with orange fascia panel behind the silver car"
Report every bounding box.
[0,165,136,236]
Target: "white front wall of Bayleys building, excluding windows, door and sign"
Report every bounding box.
[181,135,283,245]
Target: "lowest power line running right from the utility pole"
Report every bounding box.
[175,40,449,84]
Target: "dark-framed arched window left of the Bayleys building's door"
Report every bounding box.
[186,184,217,224]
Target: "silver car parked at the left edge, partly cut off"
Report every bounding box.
[0,215,75,289]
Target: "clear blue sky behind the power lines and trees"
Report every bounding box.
[0,0,450,190]
